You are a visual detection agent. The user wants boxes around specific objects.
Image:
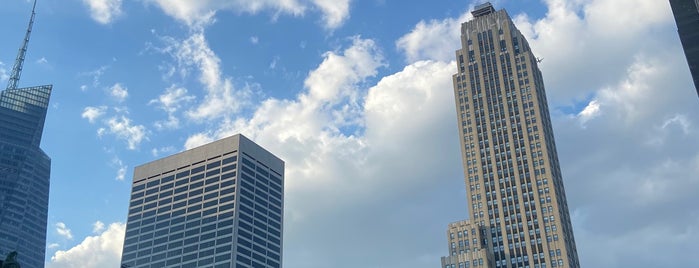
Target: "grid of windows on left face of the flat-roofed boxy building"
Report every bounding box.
[122,152,238,268]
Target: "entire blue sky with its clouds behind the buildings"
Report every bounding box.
[0,0,699,268]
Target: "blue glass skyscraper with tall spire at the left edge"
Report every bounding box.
[0,2,52,268]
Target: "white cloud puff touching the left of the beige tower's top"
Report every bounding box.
[396,9,472,62]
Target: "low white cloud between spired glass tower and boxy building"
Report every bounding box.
[46,223,126,268]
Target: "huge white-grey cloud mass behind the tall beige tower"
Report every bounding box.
[168,0,699,267]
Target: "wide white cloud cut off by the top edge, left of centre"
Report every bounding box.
[143,0,350,29]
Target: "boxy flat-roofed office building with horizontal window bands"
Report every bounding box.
[121,134,284,268]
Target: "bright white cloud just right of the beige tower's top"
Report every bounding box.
[514,0,677,103]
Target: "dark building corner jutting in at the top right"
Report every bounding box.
[670,0,699,95]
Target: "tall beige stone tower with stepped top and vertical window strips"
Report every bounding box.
[442,3,580,268]
